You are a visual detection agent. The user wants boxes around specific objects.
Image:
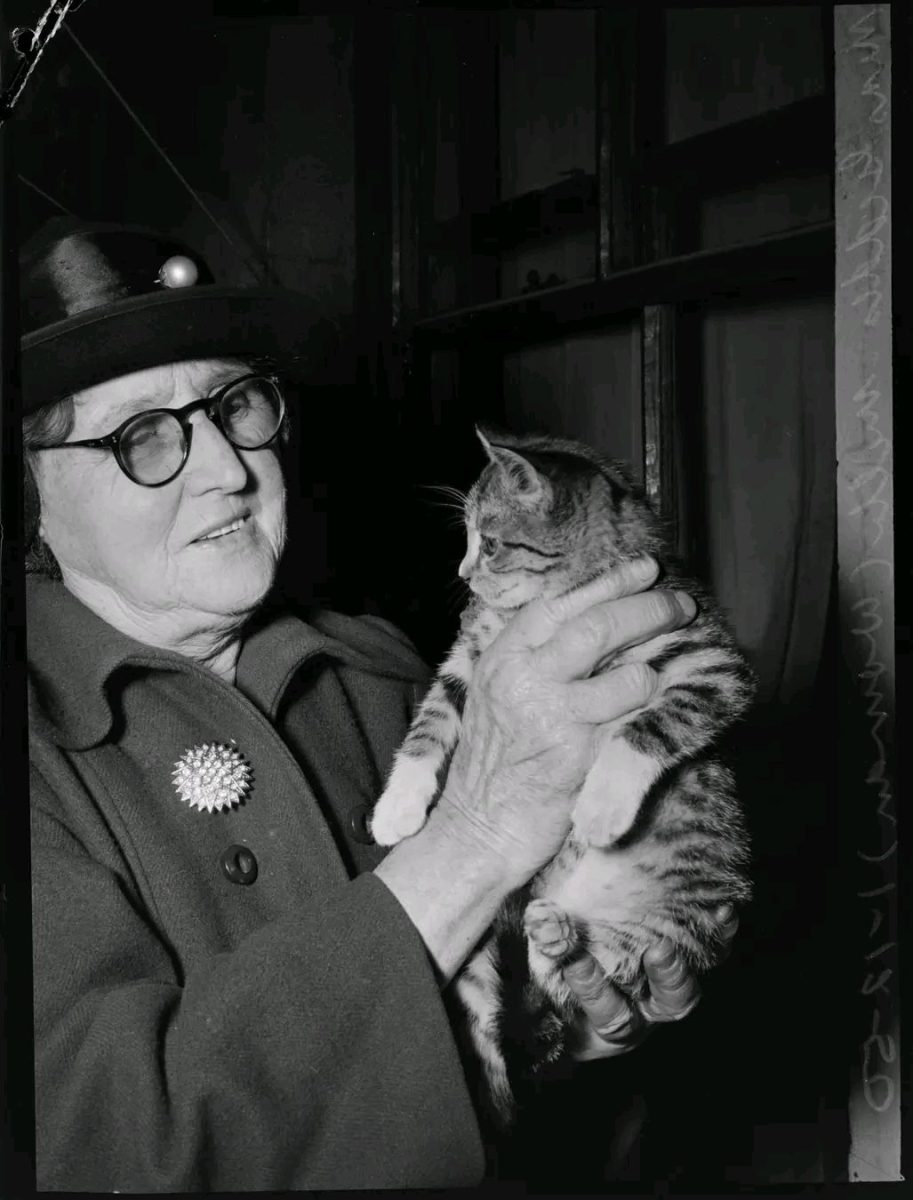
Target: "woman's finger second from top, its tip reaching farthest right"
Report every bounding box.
[534,589,697,683]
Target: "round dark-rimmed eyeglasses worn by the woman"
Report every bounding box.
[35,374,286,487]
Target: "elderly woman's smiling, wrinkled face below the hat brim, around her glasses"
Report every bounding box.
[35,359,286,649]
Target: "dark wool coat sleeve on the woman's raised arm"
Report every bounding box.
[32,776,483,1192]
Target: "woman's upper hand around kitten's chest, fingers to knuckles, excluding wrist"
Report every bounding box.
[432,559,696,886]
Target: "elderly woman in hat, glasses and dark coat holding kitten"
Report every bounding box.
[22,222,725,1192]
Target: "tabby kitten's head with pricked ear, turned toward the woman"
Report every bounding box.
[459,443,617,608]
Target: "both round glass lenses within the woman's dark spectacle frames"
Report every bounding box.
[120,379,282,484]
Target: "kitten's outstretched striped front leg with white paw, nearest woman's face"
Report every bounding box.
[371,642,473,846]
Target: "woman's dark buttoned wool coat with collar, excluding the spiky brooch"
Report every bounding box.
[28,580,483,1192]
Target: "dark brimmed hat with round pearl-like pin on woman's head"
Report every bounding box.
[19,217,338,413]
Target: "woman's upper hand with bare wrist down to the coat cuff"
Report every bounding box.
[374,559,696,984]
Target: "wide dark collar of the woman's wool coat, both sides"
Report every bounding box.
[26,576,427,750]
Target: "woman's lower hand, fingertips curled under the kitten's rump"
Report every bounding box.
[563,905,739,1061]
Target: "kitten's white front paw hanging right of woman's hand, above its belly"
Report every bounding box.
[572,738,662,847]
